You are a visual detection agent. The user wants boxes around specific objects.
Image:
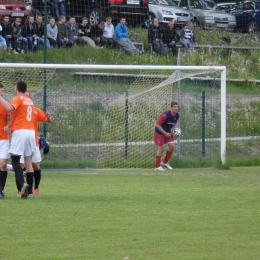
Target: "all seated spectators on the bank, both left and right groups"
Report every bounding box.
[0,15,196,55]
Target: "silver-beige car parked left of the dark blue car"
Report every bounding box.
[178,0,236,31]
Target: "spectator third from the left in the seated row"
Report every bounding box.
[23,15,39,52]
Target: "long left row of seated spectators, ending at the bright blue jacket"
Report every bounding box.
[0,15,133,54]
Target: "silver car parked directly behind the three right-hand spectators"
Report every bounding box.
[146,0,193,27]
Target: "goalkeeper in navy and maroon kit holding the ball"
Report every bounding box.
[154,101,180,171]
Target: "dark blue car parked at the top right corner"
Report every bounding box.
[231,0,260,33]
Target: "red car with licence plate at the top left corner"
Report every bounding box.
[0,0,33,21]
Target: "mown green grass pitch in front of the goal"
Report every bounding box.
[0,167,260,260]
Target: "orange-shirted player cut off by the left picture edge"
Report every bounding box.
[0,83,11,199]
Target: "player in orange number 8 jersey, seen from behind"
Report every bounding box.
[0,81,37,199]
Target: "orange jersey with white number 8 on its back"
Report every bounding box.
[11,95,34,131]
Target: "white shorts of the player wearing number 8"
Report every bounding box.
[9,129,37,157]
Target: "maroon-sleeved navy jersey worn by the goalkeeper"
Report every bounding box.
[154,110,180,135]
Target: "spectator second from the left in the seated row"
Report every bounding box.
[13,17,27,54]
